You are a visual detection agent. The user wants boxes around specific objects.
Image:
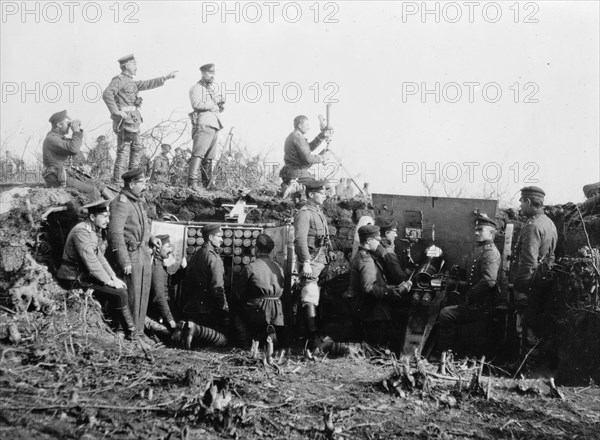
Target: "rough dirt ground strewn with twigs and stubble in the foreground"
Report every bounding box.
[0,300,600,440]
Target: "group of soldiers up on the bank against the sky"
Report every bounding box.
[43,55,340,199]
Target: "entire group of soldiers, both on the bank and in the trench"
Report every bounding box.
[43,55,557,364]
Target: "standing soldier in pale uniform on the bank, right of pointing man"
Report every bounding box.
[188,64,225,191]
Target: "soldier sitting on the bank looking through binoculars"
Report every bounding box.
[42,110,112,200]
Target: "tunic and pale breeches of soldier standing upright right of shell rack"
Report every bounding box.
[294,200,329,306]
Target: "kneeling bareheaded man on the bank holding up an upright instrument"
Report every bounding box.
[279,115,330,192]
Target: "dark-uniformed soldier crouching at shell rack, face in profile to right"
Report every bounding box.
[181,224,229,350]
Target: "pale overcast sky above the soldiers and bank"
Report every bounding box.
[0,1,600,203]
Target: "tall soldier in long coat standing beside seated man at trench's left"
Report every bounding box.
[108,168,161,333]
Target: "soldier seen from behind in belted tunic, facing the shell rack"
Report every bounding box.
[236,234,284,348]
